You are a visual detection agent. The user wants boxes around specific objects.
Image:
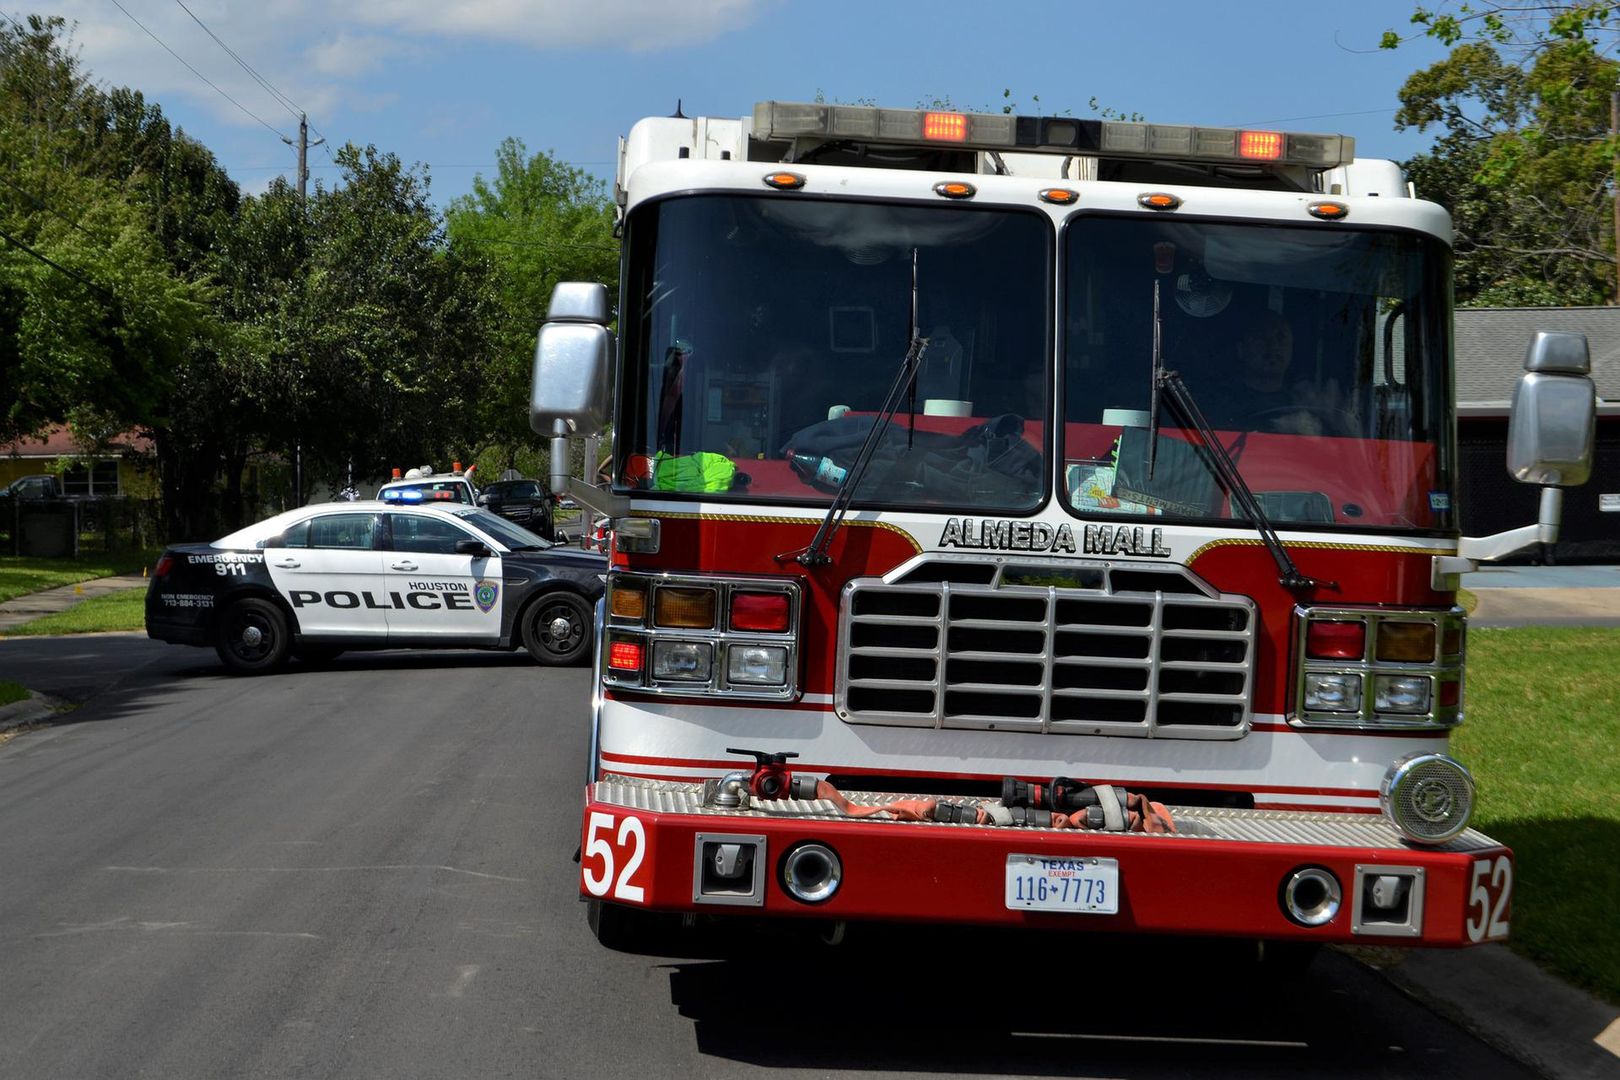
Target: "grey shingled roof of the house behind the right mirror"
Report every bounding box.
[1455,308,1620,416]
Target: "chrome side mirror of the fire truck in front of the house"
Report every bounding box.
[1508,332,1597,487]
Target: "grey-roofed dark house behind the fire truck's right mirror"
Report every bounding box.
[1455,308,1620,562]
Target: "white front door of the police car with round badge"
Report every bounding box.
[387,510,502,644]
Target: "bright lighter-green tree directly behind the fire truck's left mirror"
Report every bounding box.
[446,139,619,468]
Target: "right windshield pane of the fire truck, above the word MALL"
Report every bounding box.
[1059,215,1452,531]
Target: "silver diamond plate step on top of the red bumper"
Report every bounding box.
[596,777,1500,852]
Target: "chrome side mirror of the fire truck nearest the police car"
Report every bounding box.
[528,282,612,436]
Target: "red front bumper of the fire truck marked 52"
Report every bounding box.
[580,776,1513,946]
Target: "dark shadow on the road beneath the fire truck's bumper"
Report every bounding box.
[651,928,1528,1077]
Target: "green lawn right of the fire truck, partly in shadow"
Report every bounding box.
[1452,627,1620,1004]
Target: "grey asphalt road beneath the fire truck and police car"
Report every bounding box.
[0,636,1528,1080]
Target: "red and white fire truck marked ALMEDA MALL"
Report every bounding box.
[531,95,1594,950]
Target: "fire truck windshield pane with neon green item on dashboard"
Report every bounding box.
[616,194,1055,512]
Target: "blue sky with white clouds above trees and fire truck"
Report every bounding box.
[15,0,1443,206]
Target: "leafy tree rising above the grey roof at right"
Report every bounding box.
[1383,3,1620,304]
